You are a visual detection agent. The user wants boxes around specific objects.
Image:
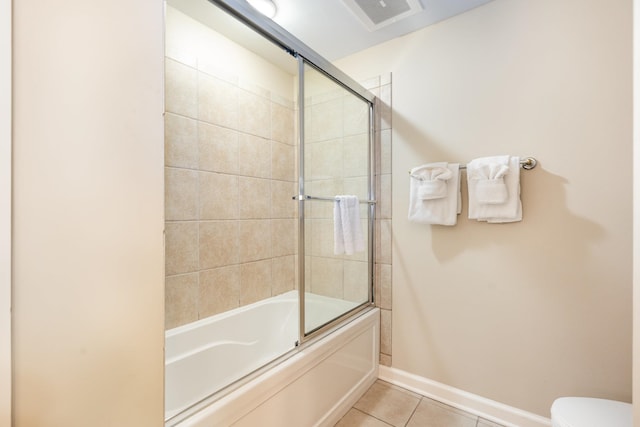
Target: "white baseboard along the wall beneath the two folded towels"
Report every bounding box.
[378,365,551,427]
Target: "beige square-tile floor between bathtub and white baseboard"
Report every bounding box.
[335,380,502,427]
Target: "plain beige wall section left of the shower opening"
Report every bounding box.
[13,0,164,427]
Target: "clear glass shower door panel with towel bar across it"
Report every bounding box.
[304,64,372,334]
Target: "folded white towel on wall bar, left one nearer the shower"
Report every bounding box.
[409,162,462,225]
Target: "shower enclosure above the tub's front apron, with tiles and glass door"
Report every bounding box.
[165,0,375,420]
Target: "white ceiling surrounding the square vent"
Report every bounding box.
[274,0,492,61]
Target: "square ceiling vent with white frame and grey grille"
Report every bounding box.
[342,0,422,31]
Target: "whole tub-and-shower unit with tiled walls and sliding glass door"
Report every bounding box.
[165,0,379,427]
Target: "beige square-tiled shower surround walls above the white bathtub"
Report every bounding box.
[165,7,391,364]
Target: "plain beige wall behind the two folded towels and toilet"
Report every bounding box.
[338,0,632,416]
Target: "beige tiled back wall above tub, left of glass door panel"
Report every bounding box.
[165,55,297,328]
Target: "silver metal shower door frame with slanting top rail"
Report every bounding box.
[208,0,376,346]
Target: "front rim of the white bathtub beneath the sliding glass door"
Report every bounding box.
[164,303,379,427]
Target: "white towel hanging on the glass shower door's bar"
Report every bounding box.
[333,195,365,255]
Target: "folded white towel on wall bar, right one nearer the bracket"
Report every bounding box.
[467,156,522,223]
